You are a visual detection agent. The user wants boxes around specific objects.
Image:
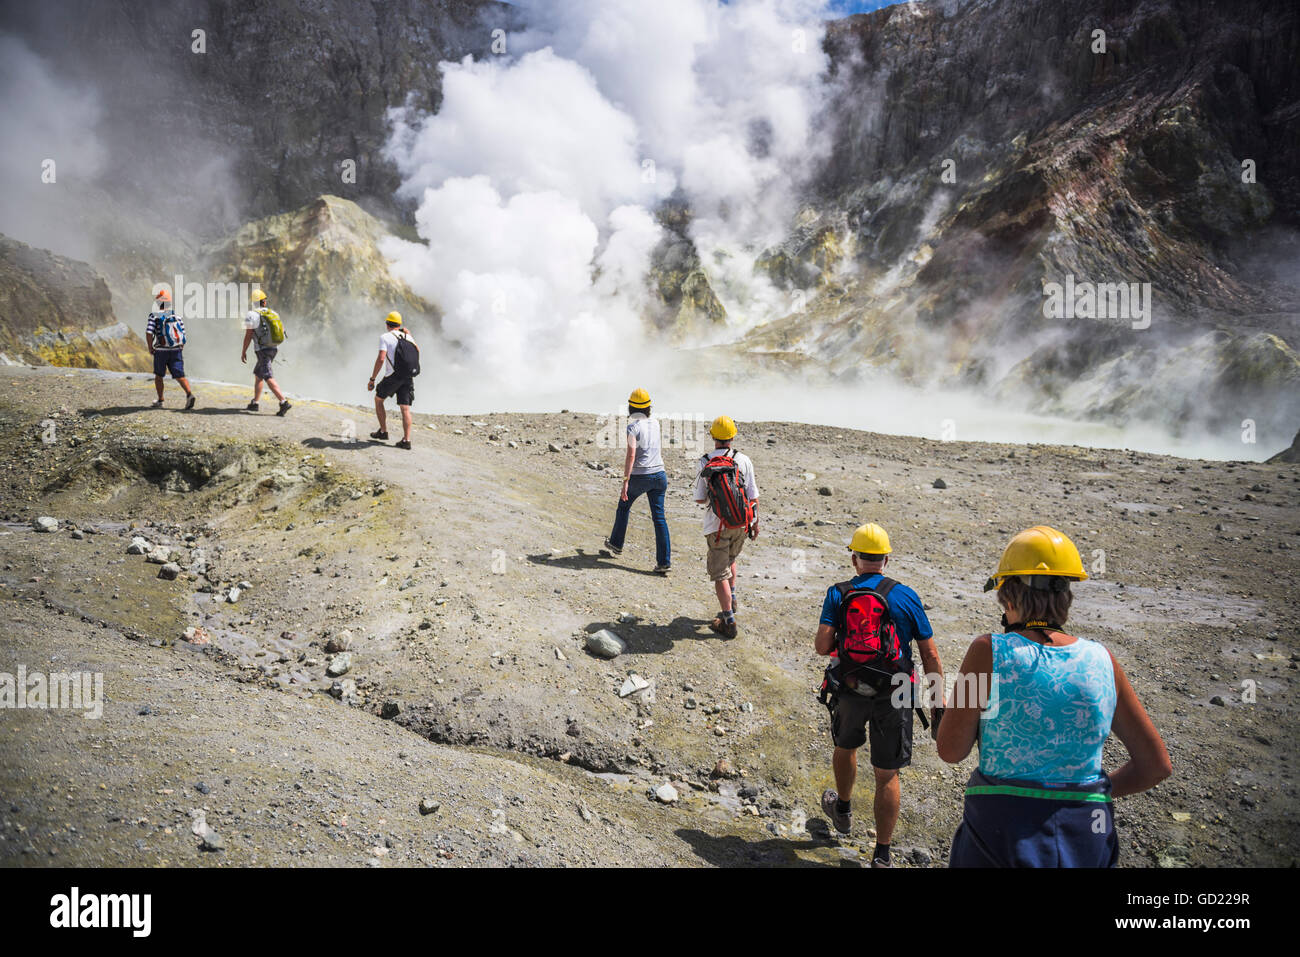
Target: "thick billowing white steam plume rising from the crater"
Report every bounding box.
[384,0,827,393]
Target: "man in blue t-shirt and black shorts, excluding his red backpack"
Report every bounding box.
[816,523,944,867]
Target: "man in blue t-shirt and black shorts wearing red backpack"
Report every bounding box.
[815,523,944,867]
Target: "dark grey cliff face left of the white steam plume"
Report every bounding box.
[0,0,512,226]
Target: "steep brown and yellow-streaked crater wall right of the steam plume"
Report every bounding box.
[748,0,1300,436]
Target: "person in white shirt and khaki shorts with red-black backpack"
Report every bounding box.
[696,415,758,638]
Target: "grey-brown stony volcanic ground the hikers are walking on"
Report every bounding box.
[0,369,1300,865]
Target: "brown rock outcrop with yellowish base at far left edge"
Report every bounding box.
[0,237,151,371]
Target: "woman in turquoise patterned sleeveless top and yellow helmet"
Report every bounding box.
[937,525,1173,867]
